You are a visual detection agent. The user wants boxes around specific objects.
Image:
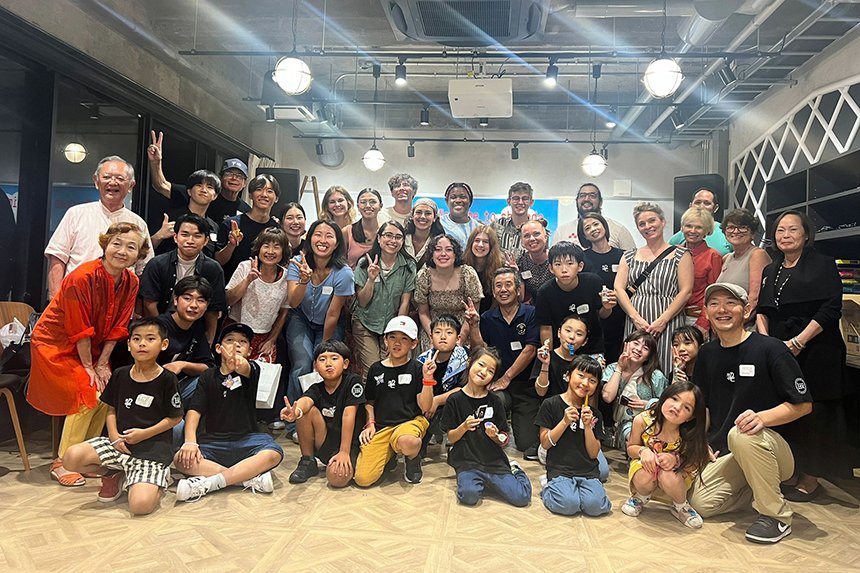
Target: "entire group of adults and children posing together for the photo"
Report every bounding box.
[18,143,845,542]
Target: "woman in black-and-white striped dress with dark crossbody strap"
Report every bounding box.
[615,203,693,369]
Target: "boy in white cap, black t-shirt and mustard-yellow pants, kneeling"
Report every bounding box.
[355,316,436,487]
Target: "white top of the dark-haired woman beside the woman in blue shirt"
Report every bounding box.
[227,261,287,334]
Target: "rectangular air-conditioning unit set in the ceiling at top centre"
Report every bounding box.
[380,0,551,46]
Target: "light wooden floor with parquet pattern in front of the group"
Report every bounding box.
[0,435,860,573]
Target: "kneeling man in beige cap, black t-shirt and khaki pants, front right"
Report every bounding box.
[690,283,812,543]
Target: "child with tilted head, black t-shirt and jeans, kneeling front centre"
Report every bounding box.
[442,346,532,507]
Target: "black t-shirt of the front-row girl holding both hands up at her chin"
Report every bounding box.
[535,396,603,480]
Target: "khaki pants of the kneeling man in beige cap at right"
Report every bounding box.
[690,428,794,524]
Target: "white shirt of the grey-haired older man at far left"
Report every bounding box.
[45,201,154,275]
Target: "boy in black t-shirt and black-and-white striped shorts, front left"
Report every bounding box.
[63,318,182,515]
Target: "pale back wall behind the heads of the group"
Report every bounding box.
[268,127,705,236]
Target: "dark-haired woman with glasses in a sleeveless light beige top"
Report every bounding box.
[717,209,770,317]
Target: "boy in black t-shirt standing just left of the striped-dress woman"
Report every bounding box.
[534,241,616,363]
